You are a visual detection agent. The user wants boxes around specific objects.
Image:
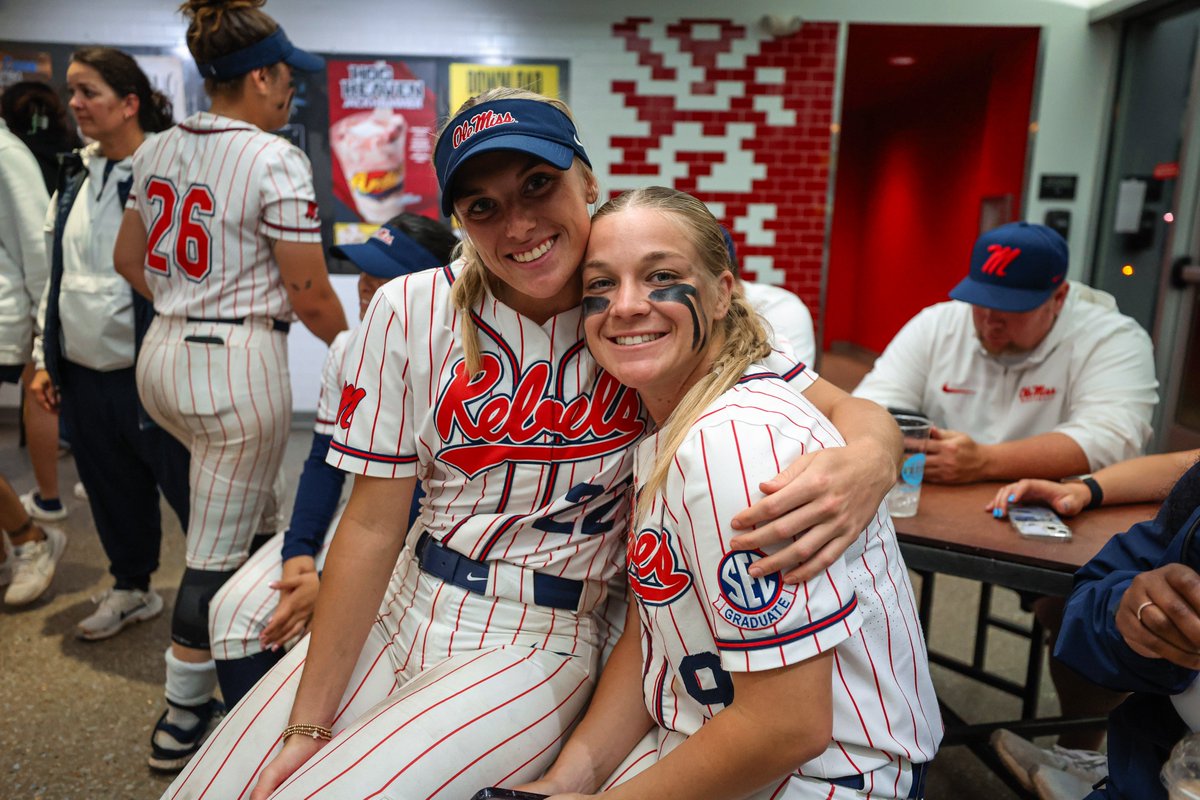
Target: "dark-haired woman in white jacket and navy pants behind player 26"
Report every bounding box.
[31,47,188,639]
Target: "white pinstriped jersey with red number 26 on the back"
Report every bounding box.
[126,112,320,319]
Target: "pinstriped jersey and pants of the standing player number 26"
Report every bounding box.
[126,113,320,571]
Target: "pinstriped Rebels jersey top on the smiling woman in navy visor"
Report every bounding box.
[330,266,644,587]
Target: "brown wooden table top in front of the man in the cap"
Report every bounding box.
[894,483,1158,572]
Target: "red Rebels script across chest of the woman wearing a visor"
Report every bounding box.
[434,353,644,476]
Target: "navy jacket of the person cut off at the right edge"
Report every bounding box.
[1054,464,1200,800]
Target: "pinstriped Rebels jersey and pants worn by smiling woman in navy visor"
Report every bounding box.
[163,265,812,800]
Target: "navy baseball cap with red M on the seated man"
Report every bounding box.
[950,222,1068,312]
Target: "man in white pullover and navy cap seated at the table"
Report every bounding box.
[854,222,1158,772]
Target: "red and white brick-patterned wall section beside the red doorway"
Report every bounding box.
[608,18,838,328]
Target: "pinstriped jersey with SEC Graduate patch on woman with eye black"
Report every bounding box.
[626,366,942,800]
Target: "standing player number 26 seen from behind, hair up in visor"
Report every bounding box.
[113,0,346,771]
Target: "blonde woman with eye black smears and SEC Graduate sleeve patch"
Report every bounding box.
[521,187,942,800]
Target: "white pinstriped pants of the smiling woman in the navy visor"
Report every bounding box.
[163,548,596,800]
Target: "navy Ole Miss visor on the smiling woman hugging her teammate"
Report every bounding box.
[433,100,592,217]
